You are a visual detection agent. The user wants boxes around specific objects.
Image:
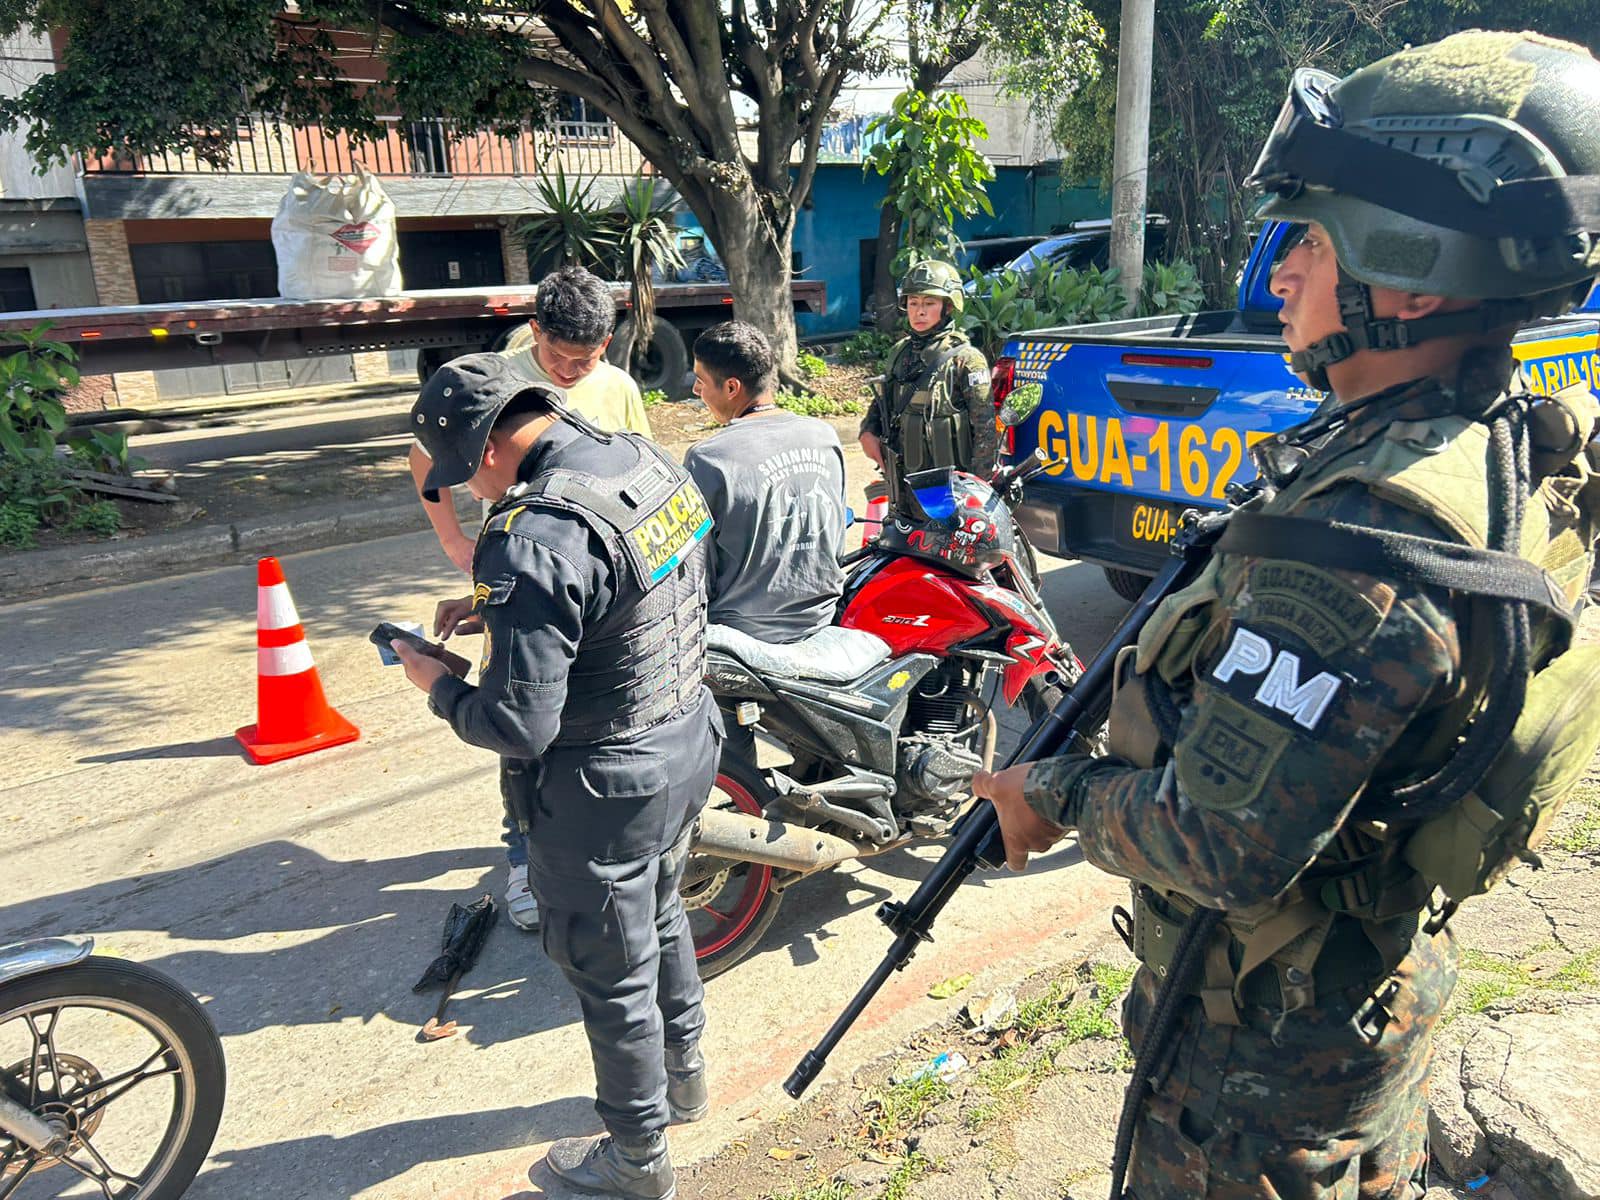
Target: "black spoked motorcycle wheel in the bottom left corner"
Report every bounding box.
[0,957,227,1200]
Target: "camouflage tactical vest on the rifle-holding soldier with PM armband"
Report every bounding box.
[1110,386,1600,1024]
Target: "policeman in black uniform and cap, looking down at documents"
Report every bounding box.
[397,354,722,1200]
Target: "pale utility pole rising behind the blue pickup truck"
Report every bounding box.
[1110,0,1155,317]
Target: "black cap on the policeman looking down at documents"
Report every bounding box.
[411,354,562,501]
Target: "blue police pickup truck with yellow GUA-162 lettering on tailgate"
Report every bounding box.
[995,222,1600,598]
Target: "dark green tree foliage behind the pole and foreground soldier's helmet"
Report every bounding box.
[1043,0,1600,302]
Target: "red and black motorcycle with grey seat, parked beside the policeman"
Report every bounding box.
[682,456,1083,978]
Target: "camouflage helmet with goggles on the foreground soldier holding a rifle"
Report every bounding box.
[1248,29,1600,305]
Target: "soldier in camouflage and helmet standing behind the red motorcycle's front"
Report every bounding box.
[861,259,1000,507]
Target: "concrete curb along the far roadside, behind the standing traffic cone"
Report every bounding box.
[0,499,464,603]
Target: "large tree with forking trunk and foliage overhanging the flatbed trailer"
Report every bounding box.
[0,0,882,378]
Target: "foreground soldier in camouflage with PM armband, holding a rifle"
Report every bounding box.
[974,30,1600,1200]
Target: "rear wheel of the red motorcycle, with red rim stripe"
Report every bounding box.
[678,754,782,979]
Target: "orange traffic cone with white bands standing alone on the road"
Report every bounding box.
[237,558,362,763]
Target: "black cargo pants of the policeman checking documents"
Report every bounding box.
[528,698,720,1138]
